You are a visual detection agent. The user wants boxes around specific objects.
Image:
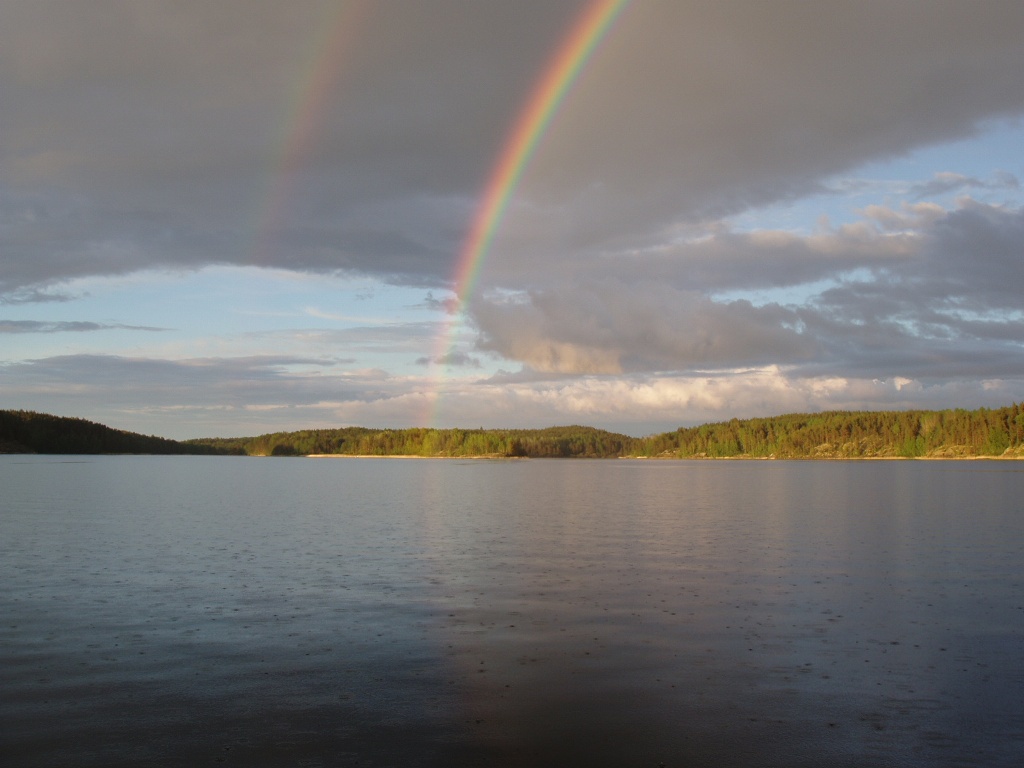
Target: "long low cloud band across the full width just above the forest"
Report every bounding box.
[8,355,1024,438]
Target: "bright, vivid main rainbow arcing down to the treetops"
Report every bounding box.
[427,0,629,424]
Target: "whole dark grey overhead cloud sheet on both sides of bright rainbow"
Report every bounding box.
[0,0,1024,296]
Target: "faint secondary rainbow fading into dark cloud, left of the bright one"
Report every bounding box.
[253,0,370,266]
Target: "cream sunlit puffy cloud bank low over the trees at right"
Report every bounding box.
[362,367,1024,435]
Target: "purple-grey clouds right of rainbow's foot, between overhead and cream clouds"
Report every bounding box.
[471,200,1024,379]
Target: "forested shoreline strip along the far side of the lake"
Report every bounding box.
[8,403,1024,459]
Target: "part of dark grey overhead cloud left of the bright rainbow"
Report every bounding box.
[0,1,578,291]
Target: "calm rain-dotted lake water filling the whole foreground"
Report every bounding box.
[0,456,1024,767]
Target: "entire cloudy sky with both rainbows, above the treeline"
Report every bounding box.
[0,0,1024,438]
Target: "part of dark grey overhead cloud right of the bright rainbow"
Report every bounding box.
[483,2,1024,252]
